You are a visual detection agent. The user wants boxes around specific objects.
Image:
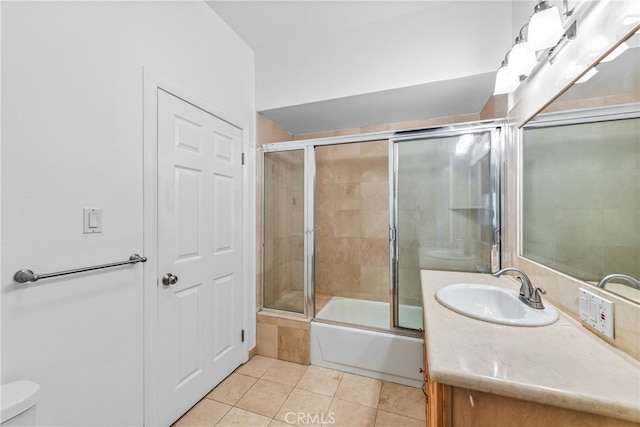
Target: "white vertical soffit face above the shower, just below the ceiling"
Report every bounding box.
[256,0,516,111]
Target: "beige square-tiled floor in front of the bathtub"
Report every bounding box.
[174,356,426,427]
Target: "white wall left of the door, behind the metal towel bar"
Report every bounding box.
[1,1,255,426]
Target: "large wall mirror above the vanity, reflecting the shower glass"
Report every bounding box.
[521,27,640,302]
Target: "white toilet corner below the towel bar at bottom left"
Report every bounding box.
[0,381,40,427]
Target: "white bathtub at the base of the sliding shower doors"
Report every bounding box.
[310,297,423,387]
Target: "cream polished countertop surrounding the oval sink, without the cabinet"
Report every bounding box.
[421,270,640,422]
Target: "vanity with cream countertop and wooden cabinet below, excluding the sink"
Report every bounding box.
[421,270,640,427]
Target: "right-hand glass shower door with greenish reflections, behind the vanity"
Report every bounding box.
[392,128,499,329]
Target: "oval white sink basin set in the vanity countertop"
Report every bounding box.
[436,283,558,326]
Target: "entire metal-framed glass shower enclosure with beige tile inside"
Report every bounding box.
[262,122,501,336]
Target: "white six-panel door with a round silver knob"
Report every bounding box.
[155,89,242,425]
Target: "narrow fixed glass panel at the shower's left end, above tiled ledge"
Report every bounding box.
[262,149,306,314]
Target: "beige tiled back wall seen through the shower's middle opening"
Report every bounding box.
[315,141,389,301]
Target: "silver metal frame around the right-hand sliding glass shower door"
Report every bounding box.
[389,120,506,331]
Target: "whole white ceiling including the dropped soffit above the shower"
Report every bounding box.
[207,0,524,135]
